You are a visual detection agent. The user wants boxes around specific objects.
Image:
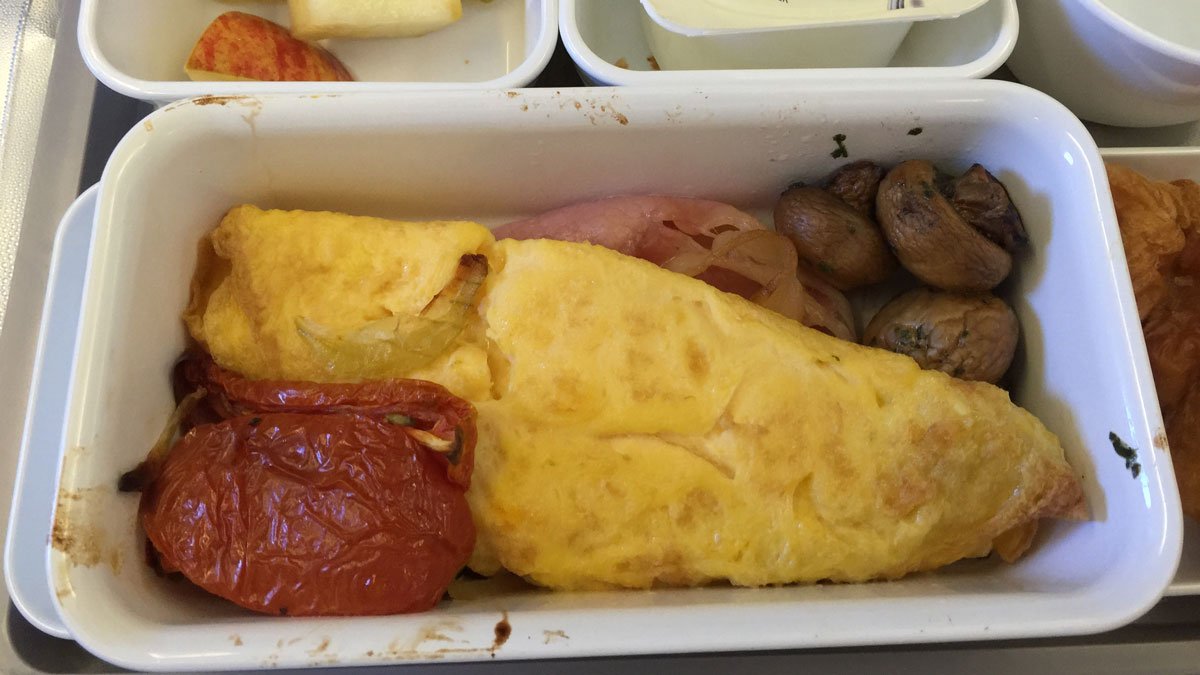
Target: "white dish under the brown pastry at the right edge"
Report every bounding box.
[1100,148,1200,596]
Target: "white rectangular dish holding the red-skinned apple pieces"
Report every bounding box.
[79,0,558,103]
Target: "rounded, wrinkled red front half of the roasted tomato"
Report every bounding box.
[139,413,475,616]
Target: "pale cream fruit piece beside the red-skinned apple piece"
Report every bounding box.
[288,0,462,40]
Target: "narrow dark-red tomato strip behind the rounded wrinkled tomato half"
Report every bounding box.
[174,352,476,488]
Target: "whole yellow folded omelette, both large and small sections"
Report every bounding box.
[185,207,1086,589]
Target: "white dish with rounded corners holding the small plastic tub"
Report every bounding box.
[559,0,1018,86]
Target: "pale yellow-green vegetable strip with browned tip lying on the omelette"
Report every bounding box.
[296,255,487,378]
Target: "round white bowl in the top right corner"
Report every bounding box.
[1009,0,1200,126]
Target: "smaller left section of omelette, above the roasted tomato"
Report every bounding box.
[184,205,493,399]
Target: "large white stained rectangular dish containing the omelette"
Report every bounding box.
[47,82,1181,670]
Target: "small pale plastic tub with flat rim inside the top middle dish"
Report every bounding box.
[642,0,985,70]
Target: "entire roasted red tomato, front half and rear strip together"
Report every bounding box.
[122,358,475,616]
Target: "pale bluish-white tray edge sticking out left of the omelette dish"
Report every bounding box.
[4,187,97,638]
